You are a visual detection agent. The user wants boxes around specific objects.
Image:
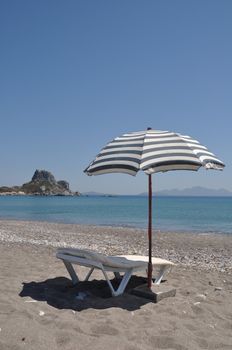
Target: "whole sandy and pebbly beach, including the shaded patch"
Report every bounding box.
[0,220,232,350]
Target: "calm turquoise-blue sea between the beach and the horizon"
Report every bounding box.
[0,196,232,234]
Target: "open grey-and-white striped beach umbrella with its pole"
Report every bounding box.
[84,128,225,288]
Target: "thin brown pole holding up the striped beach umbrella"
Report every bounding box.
[147,174,152,289]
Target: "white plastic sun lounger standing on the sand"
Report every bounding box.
[56,248,174,296]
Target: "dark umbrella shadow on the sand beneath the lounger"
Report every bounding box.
[19,276,150,311]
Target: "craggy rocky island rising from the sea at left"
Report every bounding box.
[0,169,80,196]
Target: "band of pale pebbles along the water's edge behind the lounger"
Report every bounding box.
[0,219,232,273]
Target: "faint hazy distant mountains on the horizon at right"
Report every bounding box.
[139,186,232,197]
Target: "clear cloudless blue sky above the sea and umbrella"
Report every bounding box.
[0,0,232,194]
